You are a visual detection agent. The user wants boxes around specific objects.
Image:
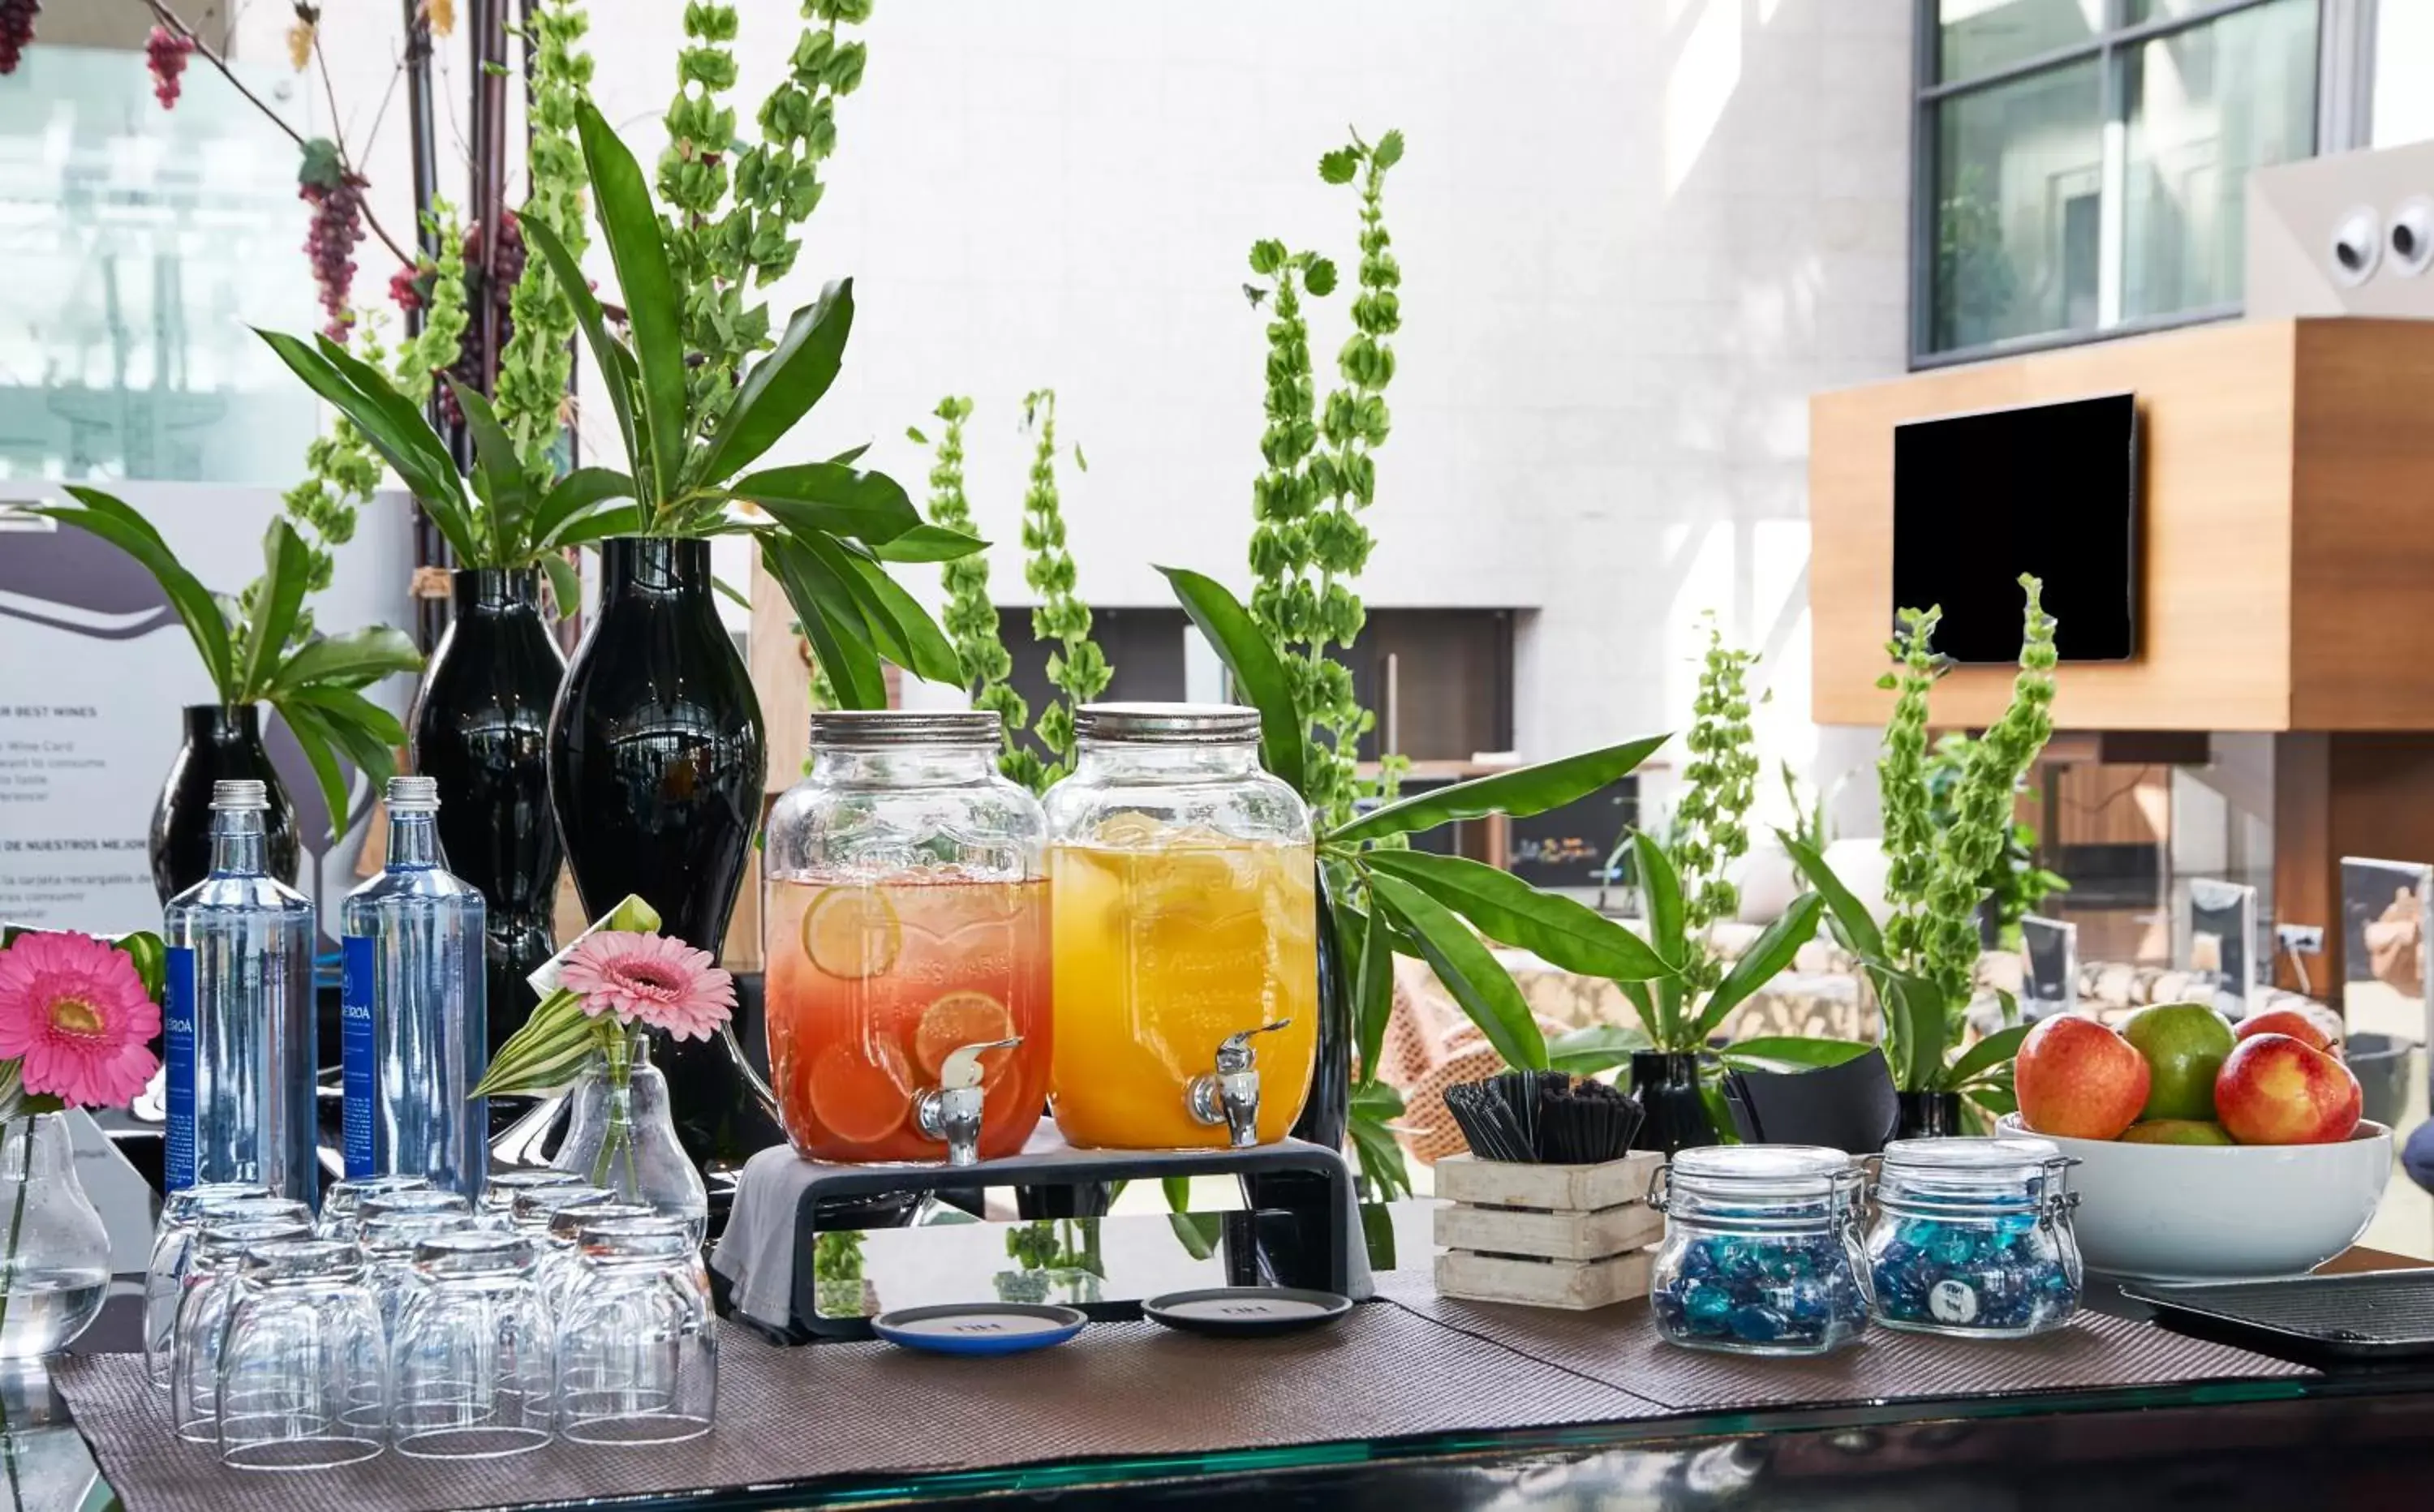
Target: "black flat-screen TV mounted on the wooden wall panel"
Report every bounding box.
[1894,394,2139,662]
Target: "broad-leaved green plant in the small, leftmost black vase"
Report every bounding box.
[29,487,424,899]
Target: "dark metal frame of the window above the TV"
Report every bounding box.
[1908,0,2327,372]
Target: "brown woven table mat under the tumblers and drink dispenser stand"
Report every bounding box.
[58,1305,1660,1512]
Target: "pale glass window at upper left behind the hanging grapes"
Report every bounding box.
[0,41,324,484]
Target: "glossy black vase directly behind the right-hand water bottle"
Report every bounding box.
[411,567,567,1050]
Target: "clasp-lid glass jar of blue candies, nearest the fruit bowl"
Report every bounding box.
[1867,1137,2081,1339]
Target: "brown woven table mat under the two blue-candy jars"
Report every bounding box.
[1378,1271,2312,1412]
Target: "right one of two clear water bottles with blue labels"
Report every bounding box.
[338,777,489,1201]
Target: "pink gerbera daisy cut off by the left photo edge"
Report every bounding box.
[0,935,161,1108]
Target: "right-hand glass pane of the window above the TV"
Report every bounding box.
[2122,0,2317,319]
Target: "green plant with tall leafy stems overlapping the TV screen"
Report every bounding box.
[1782,574,2054,1135]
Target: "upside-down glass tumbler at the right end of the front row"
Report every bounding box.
[557,1218,718,1444]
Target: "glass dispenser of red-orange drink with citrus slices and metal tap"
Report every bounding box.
[764,711,1051,1164]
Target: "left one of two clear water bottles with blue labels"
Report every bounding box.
[163,782,319,1203]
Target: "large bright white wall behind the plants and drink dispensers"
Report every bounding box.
[285,0,1913,762]
